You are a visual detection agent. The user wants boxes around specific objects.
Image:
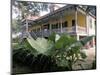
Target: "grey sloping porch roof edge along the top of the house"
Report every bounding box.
[23,5,95,26]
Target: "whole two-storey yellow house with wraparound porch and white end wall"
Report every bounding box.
[23,5,96,47]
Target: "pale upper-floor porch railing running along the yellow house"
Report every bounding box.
[30,26,86,37]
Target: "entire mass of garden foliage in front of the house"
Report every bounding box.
[14,34,92,71]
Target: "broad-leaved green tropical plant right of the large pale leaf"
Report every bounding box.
[50,34,92,70]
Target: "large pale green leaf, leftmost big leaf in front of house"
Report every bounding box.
[27,36,53,54]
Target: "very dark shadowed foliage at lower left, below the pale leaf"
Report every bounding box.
[13,48,60,72]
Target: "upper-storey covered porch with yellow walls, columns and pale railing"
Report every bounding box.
[29,7,87,37]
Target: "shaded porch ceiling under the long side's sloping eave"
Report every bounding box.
[29,10,75,26]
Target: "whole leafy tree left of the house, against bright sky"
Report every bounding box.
[12,0,48,32]
